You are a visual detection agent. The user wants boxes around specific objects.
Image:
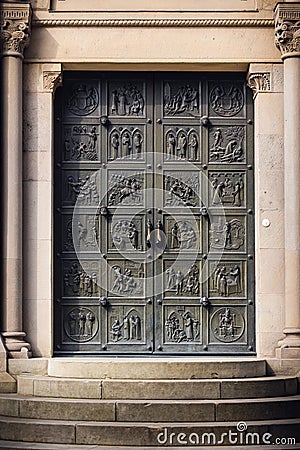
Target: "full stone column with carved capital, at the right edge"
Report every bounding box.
[275,2,300,359]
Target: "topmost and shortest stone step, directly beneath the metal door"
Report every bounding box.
[48,358,267,380]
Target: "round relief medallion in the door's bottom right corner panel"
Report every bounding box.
[210,308,245,342]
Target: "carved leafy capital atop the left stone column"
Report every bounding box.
[0,3,31,57]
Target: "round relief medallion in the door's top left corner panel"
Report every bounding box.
[66,84,99,116]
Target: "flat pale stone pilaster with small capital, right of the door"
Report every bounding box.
[248,63,285,357]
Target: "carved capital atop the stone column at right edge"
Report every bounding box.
[275,3,300,58]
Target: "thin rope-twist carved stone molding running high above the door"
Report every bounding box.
[33,19,274,28]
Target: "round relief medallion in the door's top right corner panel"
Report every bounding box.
[209,85,244,117]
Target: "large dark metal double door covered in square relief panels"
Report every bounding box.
[54,72,254,355]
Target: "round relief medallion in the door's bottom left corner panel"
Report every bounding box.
[64,307,99,342]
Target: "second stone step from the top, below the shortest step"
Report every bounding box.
[17,375,298,400]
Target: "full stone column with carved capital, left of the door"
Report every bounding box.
[0,2,31,358]
